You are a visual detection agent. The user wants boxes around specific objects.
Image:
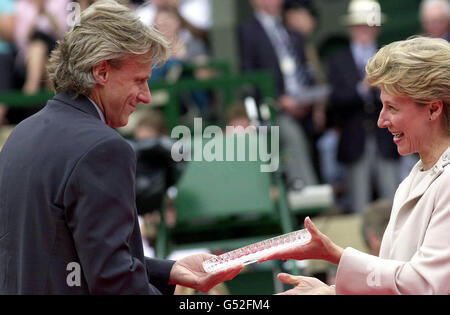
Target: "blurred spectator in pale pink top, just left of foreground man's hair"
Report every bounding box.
[15,0,70,94]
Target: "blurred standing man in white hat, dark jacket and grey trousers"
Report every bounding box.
[329,0,399,212]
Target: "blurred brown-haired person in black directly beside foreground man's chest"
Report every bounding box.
[132,109,177,270]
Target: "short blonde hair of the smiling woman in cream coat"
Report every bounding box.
[366,37,450,128]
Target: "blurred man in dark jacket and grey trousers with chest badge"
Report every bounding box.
[239,0,326,195]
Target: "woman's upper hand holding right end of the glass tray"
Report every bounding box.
[259,217,344,264]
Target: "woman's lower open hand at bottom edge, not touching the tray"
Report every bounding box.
[277,273,336,295]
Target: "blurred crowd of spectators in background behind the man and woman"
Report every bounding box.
[0,0,450,288]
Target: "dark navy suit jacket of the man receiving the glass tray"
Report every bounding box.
[0,93,174,294]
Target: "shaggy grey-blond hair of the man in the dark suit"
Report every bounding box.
[47,0,169,96]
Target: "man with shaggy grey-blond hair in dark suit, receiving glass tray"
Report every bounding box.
[0,0,242,294]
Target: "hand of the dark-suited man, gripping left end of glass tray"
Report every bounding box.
[169,254,244,292]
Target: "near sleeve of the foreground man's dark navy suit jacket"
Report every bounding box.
[64,138,169,294]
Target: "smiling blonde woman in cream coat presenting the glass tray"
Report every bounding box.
[266,37,450,294]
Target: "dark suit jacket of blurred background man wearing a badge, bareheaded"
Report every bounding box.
[238,17,313,96]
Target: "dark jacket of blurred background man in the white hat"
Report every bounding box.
[329,49,399,163]
